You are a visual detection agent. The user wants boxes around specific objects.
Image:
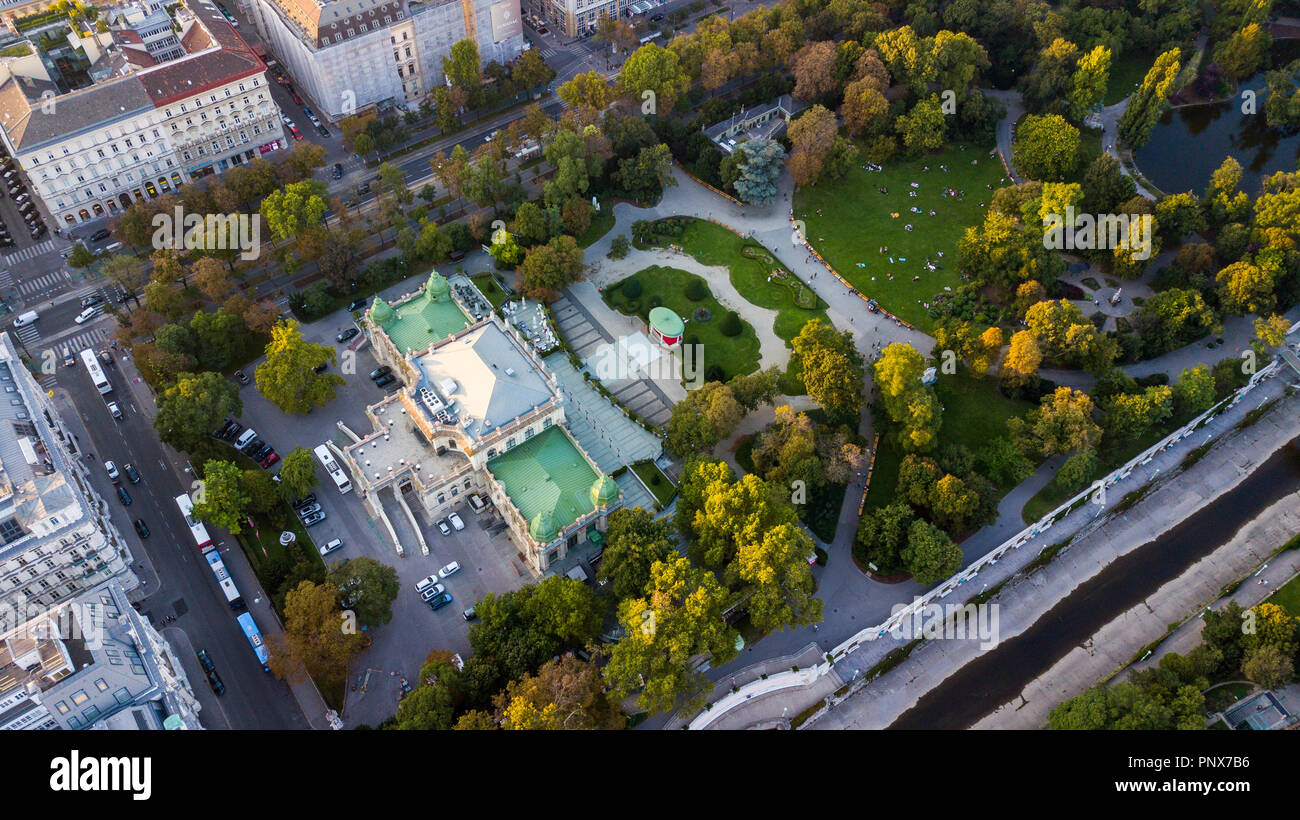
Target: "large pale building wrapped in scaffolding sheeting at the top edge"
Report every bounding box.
[247,0,524,120]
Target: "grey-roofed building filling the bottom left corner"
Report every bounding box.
[0,581,203,732]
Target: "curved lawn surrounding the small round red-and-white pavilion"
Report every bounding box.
[605,265,759,381]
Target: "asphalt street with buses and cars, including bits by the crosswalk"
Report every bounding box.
[52,304,309,729]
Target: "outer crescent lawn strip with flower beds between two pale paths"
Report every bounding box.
[677,220,831,344]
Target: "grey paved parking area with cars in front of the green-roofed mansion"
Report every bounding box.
[226,298,532,728]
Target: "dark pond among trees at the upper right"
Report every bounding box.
[1136,40,1300,196]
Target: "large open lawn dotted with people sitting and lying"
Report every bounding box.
[794,146,1005,331]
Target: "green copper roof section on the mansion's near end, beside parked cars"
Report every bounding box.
[488,426,605,543]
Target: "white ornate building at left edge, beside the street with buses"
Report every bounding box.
[0,334,139,632]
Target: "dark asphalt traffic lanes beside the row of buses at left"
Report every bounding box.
[60,366,307,729]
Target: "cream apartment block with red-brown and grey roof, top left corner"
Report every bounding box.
[0,0,286,226]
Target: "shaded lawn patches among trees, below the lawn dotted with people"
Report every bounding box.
[866,370,1034,509]
